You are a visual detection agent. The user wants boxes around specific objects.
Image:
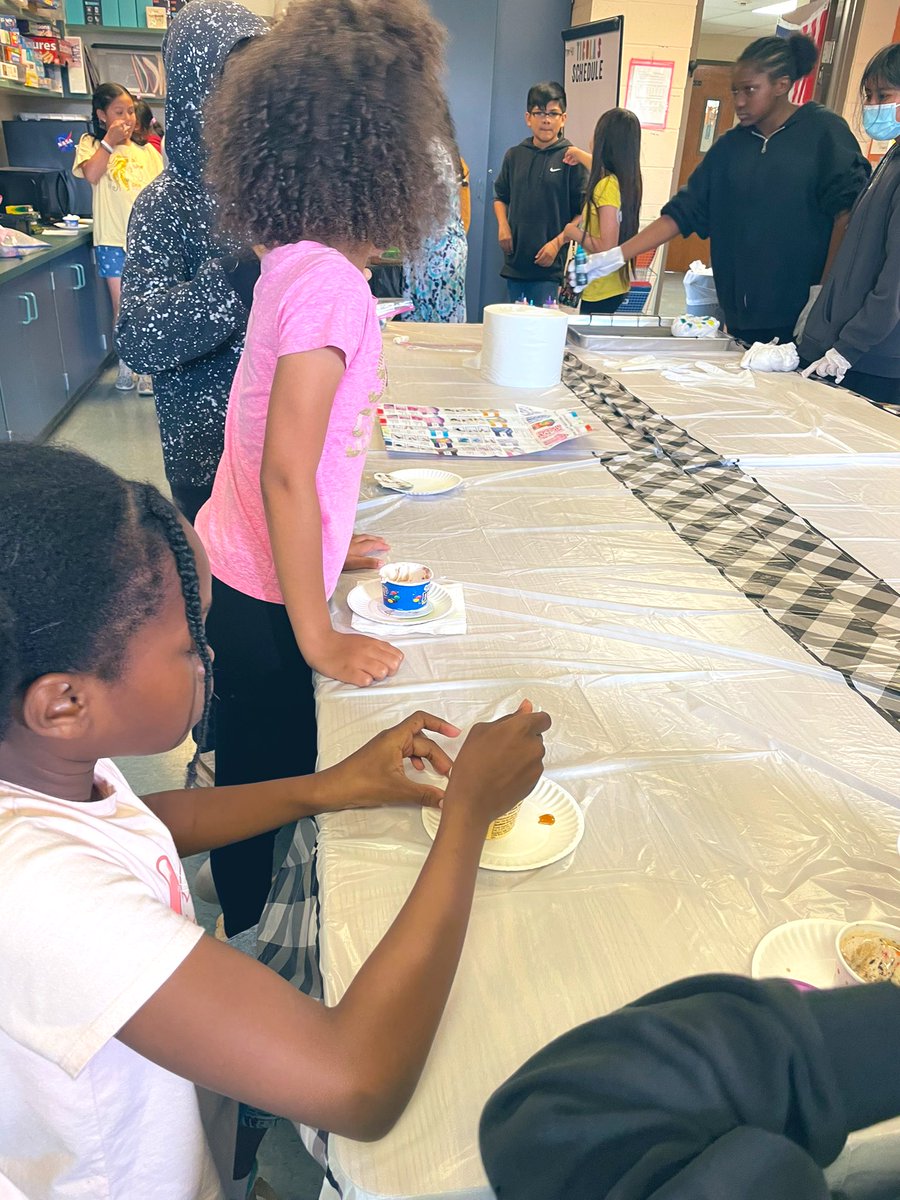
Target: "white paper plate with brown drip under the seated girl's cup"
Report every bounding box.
[422,778,584,871]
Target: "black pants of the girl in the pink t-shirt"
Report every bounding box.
[206,578,316,937]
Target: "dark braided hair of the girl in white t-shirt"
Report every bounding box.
[0,443,212,787]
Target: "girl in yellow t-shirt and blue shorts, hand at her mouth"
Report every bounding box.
[72,83,162,391]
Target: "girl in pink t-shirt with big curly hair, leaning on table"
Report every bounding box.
[197,0,446,936]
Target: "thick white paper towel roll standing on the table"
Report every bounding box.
[481,304,569,388]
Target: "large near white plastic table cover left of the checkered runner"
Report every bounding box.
[296,326,900,1200]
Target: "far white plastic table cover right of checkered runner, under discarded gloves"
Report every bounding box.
[575,342,900,470]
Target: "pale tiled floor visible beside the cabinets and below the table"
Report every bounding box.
[50,368,322,1200]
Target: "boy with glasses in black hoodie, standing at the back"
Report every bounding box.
[493,83,588,306]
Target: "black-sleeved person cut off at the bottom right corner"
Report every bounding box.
[480,976,900,1200]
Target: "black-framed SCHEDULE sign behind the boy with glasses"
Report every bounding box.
[562,17,624,150]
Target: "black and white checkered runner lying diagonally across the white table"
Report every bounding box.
[563,355,900,726]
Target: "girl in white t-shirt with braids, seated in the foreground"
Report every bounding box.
[0,444,550,1200]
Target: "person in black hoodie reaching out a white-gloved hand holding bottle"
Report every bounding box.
[571,34,869,344]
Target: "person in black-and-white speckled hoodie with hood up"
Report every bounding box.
[115,0,269,521]
